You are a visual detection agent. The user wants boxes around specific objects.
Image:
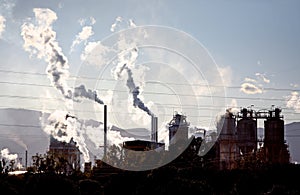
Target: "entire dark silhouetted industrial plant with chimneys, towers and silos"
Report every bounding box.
[19,105,290,174]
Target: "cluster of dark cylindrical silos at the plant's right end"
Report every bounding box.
[206,107,290,169]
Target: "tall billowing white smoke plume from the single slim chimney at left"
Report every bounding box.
[21,8,103,104]
